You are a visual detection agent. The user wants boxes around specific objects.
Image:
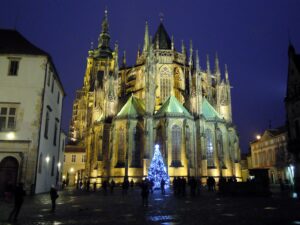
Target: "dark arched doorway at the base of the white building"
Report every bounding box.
[0,156,19,192]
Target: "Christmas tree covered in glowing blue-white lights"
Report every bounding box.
[148,145,170,188]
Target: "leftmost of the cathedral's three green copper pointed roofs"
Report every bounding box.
[117,96,145,118]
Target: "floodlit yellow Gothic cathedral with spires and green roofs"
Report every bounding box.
[70,11,241,182]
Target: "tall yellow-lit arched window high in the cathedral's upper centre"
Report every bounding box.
[160,67,171,103]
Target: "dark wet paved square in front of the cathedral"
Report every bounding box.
[0,188,300,225]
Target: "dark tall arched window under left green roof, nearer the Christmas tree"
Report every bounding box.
[131,127,143,167]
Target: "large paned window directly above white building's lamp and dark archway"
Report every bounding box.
[0,104,17,131]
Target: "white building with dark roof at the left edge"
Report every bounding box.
[0,29,65,193]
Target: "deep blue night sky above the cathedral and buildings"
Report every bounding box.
[0,0,300,152]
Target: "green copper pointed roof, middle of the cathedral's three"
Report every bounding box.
[155,96,192,117]
